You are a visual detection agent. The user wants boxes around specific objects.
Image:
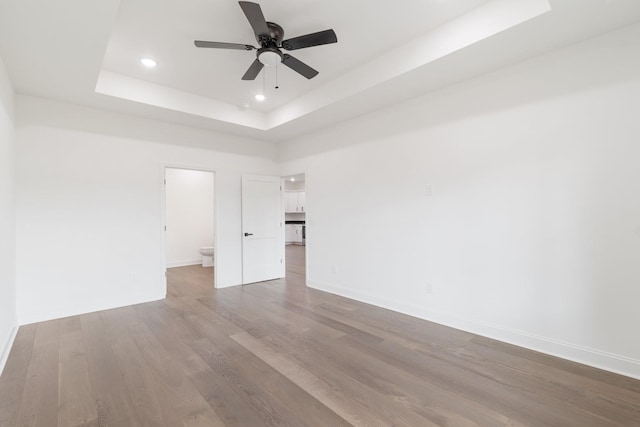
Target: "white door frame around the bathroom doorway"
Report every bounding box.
[160,163,220,297]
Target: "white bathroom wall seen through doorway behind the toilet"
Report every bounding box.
[165,168,214,267]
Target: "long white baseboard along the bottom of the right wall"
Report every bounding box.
[307,280,640,379]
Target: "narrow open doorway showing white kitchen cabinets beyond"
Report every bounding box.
[282,173,307,286]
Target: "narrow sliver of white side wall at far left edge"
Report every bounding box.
[0,54,16,373]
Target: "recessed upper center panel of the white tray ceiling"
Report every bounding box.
[102,0,488,112]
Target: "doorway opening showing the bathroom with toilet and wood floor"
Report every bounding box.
[163,166,217,297]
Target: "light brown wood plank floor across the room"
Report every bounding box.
[0,246,640,427]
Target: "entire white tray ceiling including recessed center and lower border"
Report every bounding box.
[0,0,640,141]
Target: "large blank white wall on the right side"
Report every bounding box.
[280,26,640,377]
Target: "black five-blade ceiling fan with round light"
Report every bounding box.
[194,1,338,80]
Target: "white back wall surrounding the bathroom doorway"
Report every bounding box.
[16,96,277,323]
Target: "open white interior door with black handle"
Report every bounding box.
[242,175,284,284]
